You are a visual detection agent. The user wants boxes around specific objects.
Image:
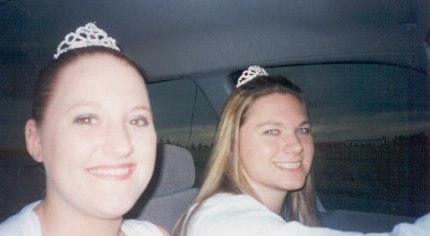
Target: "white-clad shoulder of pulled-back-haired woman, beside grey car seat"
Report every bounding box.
[121,220,169,236]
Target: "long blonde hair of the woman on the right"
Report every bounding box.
[173,76,318,235]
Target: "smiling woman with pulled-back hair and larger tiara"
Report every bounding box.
[0,23,167,236]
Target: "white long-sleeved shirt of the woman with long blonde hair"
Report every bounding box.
[187,193,430,236]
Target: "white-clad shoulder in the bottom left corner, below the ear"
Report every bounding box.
[0,201,42,236]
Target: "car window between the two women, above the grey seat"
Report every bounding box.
[148,79,218,186]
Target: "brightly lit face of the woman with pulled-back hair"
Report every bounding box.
[34,54,156,218]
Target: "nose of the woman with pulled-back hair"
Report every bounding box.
[104,125,133,158]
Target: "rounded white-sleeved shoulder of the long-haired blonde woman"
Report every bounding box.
[188,193,285,236]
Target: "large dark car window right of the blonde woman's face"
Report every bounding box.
[268,64,430,216]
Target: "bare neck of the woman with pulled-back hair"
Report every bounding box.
[34,199,124,236]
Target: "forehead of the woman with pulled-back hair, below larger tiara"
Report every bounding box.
[52,55,149,107]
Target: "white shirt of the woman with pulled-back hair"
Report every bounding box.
[0,201,162,236]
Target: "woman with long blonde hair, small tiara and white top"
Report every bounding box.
[173,66,430,236]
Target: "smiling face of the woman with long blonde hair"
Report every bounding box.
[239,93,314,203]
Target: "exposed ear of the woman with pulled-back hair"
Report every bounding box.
[25,119,43,162]
